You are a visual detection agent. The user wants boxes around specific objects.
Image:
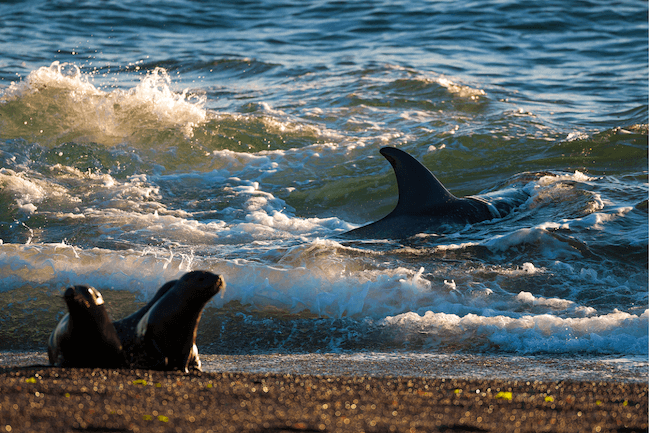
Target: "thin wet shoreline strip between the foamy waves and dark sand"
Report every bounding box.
[0,348,649,383]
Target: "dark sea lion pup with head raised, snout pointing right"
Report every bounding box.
[132,271,226,373]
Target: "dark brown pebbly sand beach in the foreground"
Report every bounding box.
[0,367,648,433]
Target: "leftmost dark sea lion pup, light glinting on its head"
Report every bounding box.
[47,286,125,368]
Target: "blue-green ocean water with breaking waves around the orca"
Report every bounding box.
[0,0,648,378]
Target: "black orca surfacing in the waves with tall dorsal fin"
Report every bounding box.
[340,147,514,239]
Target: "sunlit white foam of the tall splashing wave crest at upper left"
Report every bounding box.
[0,61,207,146]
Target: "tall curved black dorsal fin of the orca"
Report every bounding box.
[379,147,458,215]
